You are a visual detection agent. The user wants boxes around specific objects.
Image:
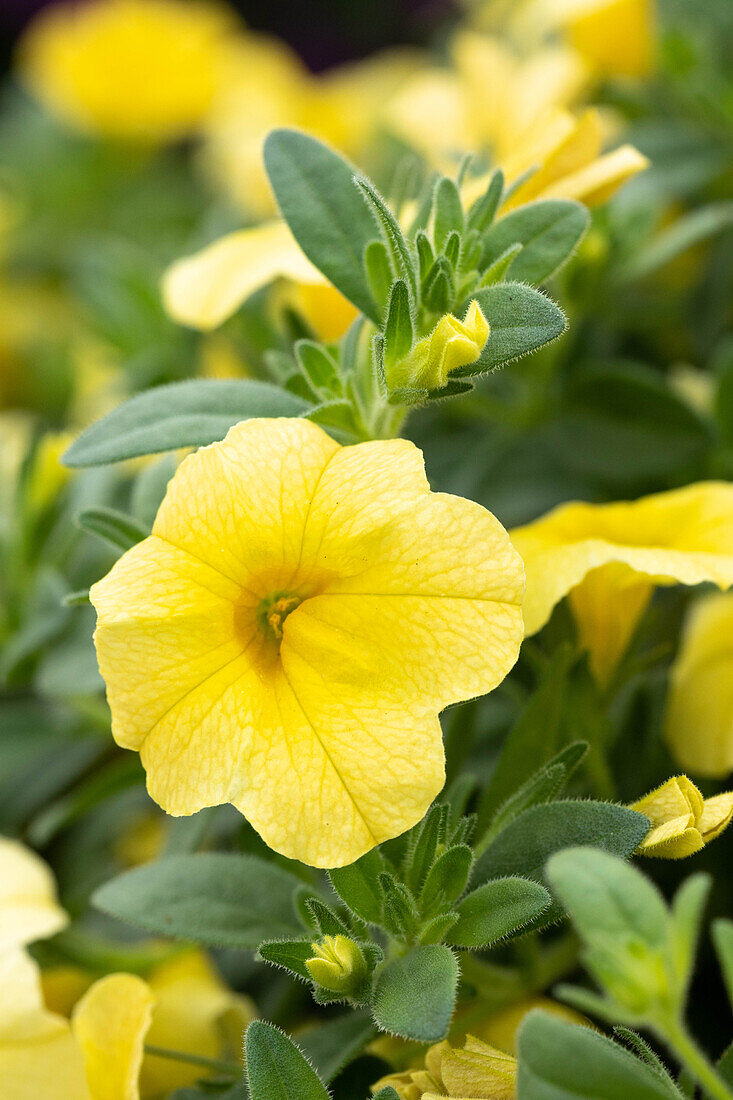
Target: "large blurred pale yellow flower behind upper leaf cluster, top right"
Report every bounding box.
[385,31,648,208]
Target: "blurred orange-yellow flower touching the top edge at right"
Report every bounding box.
[548,0,654,78]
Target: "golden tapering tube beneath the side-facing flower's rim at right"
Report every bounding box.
[569,562,654,683]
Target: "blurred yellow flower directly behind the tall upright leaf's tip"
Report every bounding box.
[201,35,422,218]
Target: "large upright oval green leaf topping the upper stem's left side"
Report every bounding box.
[264,130,381,323]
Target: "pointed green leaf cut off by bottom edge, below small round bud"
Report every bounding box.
[244,1020,328,1100]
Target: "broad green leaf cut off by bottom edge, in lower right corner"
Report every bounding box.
[517,1010,677,1100]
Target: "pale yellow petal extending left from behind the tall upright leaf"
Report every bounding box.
[163,221,326,330]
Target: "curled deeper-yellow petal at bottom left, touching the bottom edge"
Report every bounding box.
[72,974,154,1100]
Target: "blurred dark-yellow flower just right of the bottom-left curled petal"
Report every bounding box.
[140,950,255,1097]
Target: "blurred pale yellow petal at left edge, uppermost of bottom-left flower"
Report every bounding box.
[0,837,68,952]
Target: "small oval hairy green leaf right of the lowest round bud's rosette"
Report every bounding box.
[446,878,551,947]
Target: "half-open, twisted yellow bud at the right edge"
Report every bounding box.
[631,776,733,859]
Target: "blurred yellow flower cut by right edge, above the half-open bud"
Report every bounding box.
[665,593,733,778]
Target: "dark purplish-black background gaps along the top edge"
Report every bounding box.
[0,0,456,70]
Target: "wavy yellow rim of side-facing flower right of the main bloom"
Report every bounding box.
[511,482,733,635]
